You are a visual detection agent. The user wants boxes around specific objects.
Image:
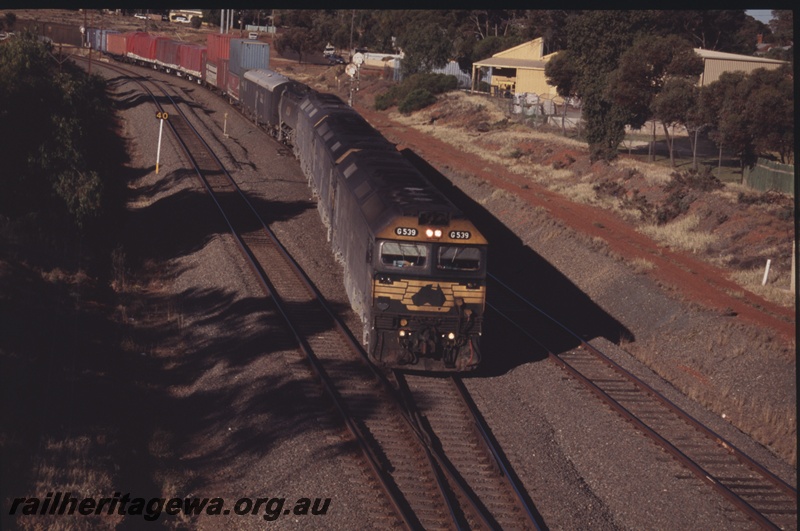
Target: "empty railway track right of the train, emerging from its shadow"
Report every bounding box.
[487,275,797,529]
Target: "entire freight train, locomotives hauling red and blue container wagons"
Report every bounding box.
[88,29,488,371]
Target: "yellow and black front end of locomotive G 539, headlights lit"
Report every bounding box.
[369,215,487,371]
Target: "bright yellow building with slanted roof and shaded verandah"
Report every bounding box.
[472,37,556,98]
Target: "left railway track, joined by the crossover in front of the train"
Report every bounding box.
[83,56,538,529]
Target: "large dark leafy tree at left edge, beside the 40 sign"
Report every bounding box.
[0,34,112,226]
